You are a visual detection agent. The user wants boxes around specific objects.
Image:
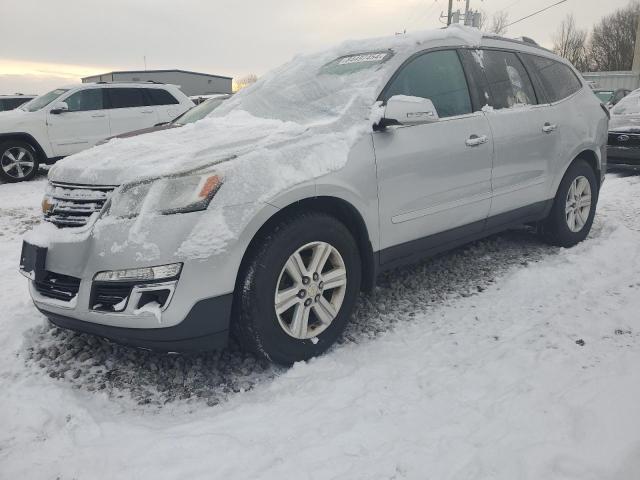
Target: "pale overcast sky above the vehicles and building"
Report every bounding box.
[0,0,628,93]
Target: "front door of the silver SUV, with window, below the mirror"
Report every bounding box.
[373,50,493,263]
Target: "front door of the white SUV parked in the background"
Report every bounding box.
[47,88,111,157]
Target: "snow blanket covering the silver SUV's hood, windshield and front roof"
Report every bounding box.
[49,26,481,190]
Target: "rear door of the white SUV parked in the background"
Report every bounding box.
[107,87,159,135]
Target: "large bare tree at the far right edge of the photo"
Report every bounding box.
[588,0,640,71]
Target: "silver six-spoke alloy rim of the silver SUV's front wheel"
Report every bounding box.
[274,242,347,340]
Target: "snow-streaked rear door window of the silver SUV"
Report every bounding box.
[471,50,538,109]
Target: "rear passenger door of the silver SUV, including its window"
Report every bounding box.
[463,49,558,223]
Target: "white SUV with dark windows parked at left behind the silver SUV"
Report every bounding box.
[0,83,193,182]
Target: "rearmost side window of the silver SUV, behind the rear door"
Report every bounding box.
[522,54,582,103]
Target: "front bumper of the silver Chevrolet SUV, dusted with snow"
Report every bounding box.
[25,201,275,351]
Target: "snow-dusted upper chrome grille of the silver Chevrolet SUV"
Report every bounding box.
[43,183,115,227]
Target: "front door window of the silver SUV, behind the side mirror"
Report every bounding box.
[382,50,473,118]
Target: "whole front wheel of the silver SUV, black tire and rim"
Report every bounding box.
[232,213,362,365]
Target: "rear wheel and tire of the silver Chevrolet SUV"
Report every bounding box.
[543,159,599,248]
